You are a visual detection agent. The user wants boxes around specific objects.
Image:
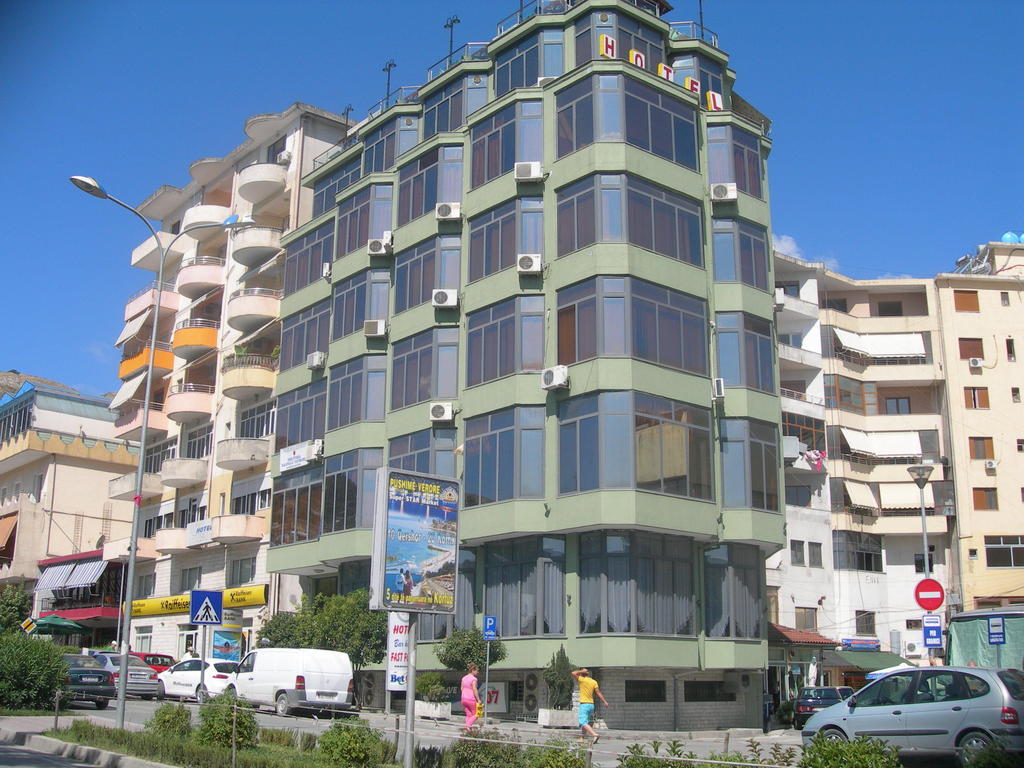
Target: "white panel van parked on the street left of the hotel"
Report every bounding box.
[225,648,352,715]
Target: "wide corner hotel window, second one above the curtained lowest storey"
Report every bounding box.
[557,278,709,376]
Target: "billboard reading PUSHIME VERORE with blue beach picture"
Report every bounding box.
[370,468,462,613]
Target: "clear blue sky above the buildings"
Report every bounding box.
[0,0,1024,393]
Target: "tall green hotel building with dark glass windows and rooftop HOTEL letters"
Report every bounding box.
[267,0,784,729]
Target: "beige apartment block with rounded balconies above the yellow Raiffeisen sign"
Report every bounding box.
[110,103,346,657]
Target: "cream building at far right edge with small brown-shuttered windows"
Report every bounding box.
[935,243,1024,609]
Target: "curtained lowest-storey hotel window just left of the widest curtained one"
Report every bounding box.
[483,536,565,637]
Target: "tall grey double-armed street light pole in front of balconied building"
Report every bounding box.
[71,176,239,729]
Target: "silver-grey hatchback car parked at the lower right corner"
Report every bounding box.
[803,667,1024,753]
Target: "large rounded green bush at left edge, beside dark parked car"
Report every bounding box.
[0,632,68,710]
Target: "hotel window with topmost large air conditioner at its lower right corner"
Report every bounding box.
[470,101,544,188]
